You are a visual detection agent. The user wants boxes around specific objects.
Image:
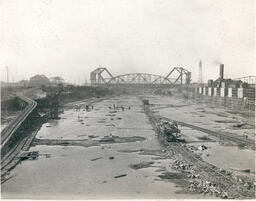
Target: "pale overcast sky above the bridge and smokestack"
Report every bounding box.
[0,0,255,83]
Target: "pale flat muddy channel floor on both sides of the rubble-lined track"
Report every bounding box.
[2,96,255,199]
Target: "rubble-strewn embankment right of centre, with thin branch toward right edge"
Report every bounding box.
[144,100,255,199]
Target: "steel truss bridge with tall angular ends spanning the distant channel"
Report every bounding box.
[90,67,191,87]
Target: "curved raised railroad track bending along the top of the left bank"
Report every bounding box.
[1,95,37,148]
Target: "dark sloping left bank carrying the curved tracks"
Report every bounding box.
[1,88,112,183]
